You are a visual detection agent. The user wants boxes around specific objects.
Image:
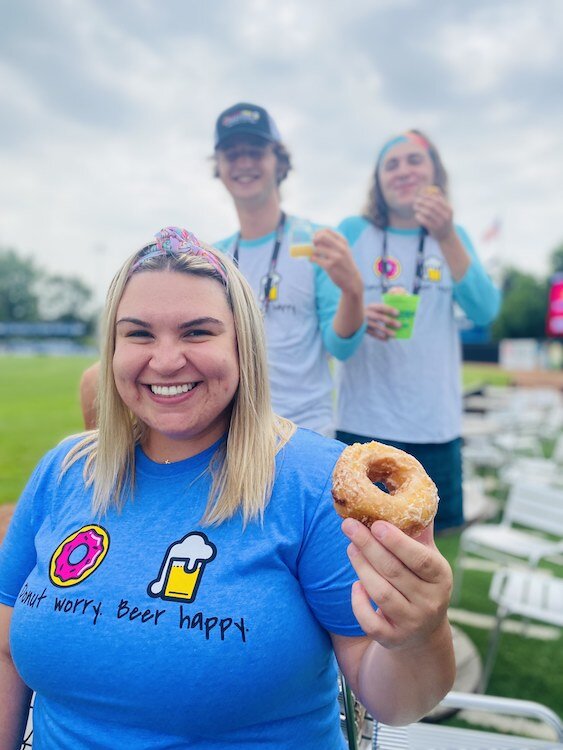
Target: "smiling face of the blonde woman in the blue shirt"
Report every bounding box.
[113,271,239,463]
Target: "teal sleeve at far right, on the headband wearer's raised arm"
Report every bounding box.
[453,226,501,326]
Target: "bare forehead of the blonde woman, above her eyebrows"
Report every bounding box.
[117,271,231,318]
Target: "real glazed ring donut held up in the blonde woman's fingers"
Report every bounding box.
[332,441,438,536]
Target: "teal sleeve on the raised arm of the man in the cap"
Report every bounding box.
[315,220,367,360]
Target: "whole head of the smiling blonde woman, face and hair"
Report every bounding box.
[80,229,280,520]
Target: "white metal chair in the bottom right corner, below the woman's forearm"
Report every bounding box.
[372,692,563,750]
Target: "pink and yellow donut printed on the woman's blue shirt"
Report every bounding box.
[49,524,109,586]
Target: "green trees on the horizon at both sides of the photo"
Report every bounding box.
[0,243,563,341]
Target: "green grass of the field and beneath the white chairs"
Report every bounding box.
[0,357,563,721]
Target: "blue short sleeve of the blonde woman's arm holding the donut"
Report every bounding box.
[298,470,364,636]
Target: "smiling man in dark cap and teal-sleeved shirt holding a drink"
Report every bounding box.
[214,103,364,435]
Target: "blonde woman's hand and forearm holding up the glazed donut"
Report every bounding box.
[332,518,456,726]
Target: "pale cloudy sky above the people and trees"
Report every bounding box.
[0,0,563,306]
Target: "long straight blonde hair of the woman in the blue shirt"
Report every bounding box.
[62,232,296,525]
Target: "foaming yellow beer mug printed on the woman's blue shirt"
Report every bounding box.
[147,531,217,602]
